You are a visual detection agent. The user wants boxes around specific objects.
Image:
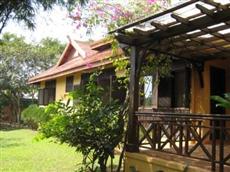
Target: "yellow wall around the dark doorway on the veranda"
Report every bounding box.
[191,59,230,114]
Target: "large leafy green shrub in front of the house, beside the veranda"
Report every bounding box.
[39,74,124,172]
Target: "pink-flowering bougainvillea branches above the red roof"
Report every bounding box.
[70,0,170,30]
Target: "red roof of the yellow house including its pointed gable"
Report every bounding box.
[28,38,122,84]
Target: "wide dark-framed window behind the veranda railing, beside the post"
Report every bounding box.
[140,64,190,109]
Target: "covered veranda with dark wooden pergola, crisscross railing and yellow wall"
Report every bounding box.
[113,0,230,171]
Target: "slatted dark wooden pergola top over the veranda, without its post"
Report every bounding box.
[112,0,230,61]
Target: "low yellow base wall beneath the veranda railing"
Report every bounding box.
[125,152,207,172]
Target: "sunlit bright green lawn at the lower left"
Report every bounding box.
[0,129,82,172]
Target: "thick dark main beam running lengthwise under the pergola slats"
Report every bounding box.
[126,8,230,45]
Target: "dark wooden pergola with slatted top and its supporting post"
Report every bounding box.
[111,0,230,170]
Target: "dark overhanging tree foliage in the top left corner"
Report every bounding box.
[0,0,87,34]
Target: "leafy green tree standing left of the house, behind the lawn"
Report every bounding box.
[0,33,63,122]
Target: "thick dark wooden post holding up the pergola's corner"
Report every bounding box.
[127,46,140,152]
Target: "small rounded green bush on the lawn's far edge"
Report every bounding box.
[22,104,49,129]
